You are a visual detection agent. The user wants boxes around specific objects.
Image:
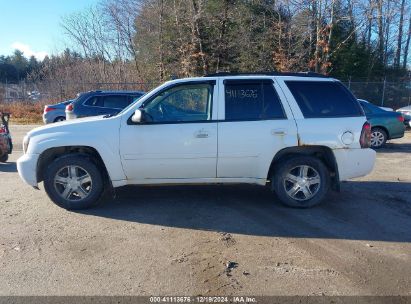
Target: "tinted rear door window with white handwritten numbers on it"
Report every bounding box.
[224,80,285,120]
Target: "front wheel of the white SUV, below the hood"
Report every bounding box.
[44,154,104,210]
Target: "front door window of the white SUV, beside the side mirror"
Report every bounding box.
[144,83,213,123]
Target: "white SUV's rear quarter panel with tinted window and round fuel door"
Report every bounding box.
[277,77,366,149]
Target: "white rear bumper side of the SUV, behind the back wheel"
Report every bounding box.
[333,149,376,181]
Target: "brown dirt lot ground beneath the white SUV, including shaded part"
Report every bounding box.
[0,126,411,295]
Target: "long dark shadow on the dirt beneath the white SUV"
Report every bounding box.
[78,182,411,242]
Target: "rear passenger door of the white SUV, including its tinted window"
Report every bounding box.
[217,78,297,181]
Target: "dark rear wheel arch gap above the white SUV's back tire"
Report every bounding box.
[267,146,340,191]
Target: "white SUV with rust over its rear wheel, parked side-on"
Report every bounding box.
[17,73,375,209]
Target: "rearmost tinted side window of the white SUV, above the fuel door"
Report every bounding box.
[285,81,363,118]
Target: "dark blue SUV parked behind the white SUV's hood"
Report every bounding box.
[66,91,145,119]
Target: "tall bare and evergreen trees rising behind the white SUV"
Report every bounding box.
[0,0,411,84]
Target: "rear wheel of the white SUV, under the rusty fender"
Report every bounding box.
[271,156,330,208]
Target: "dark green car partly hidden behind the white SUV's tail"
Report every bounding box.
[358,99,405,149]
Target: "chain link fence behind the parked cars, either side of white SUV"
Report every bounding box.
[0,80,411,109]
